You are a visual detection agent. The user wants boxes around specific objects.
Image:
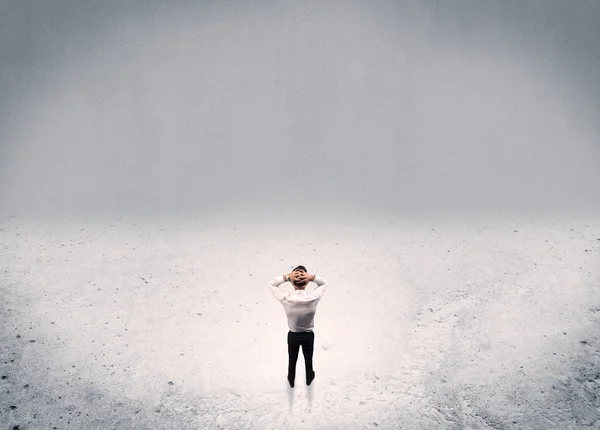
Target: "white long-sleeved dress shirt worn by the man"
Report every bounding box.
[269,275,327,332]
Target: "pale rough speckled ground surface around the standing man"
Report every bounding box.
[0,216,600,430]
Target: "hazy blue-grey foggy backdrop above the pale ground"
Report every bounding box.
[0,0,600,216]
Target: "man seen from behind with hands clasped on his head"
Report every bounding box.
[269,266,327,388]
